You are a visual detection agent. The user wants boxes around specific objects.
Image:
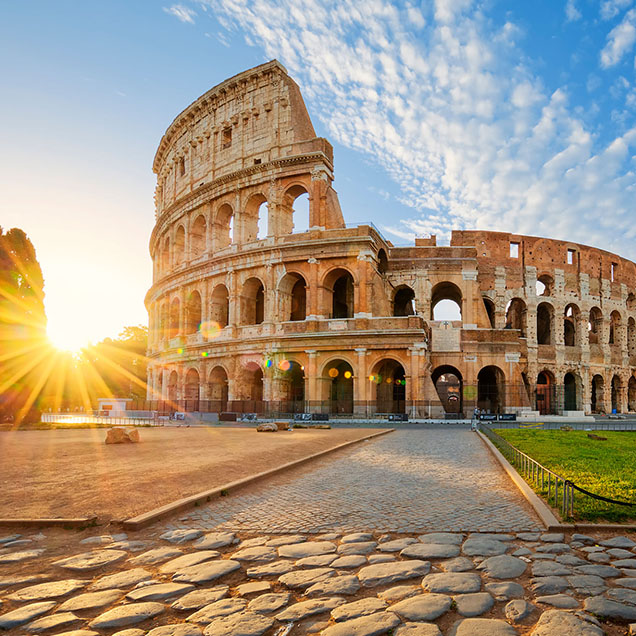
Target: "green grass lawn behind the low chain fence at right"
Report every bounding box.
[496,429,636,522]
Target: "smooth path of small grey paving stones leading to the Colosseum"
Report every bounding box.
[178,427,541,533]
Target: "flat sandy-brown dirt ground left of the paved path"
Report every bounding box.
[0,427,378,521]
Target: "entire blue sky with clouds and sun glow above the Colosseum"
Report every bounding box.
[0,0,636,342]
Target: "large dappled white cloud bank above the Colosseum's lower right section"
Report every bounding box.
[207,0,636,255]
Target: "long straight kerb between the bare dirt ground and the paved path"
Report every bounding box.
[121,428,395,530]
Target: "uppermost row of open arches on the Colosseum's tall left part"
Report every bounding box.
[155,184,309,274]
